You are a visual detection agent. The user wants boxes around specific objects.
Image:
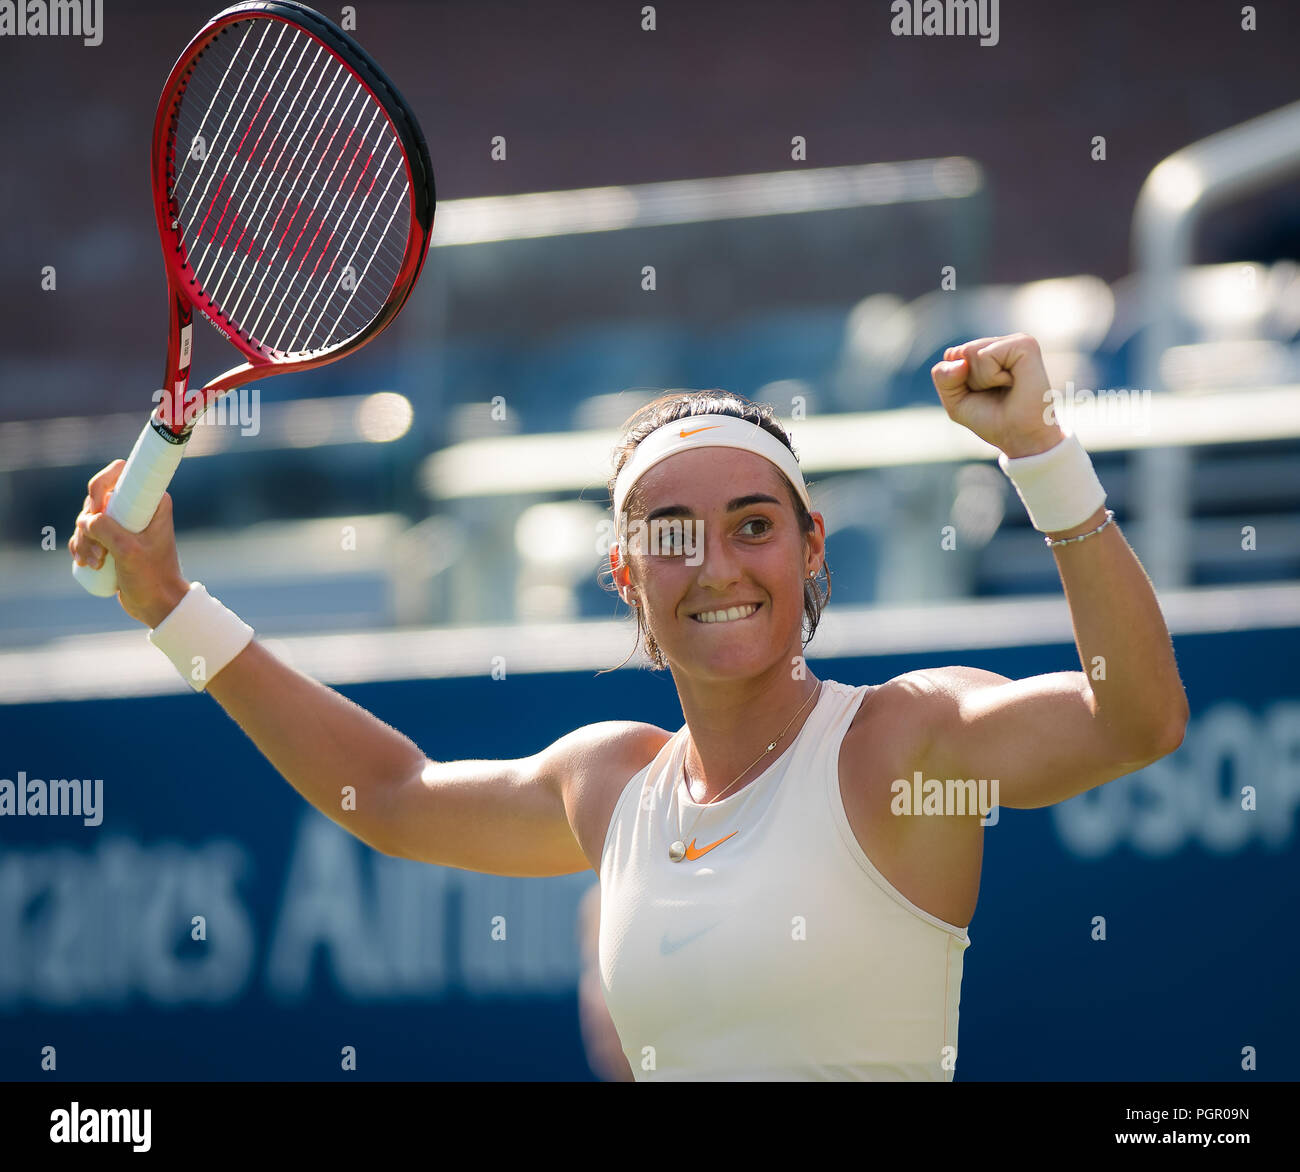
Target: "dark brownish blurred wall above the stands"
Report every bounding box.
[0,0,1300,420]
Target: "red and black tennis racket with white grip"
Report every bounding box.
[73,0,434,596]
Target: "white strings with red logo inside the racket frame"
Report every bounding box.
[172,19,411,353]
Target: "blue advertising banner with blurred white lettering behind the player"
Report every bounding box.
[0,628,1300,1081]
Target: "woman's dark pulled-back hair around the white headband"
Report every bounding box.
[597,389,831,674]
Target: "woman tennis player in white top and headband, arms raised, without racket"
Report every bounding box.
[70,334,1188,1081]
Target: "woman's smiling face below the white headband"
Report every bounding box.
[611,447,826,680]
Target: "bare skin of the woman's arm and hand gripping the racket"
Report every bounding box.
[69,460,603,876]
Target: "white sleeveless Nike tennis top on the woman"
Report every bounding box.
[599,680,970,1082]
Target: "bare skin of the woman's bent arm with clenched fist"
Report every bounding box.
[920,334,1188,808]
